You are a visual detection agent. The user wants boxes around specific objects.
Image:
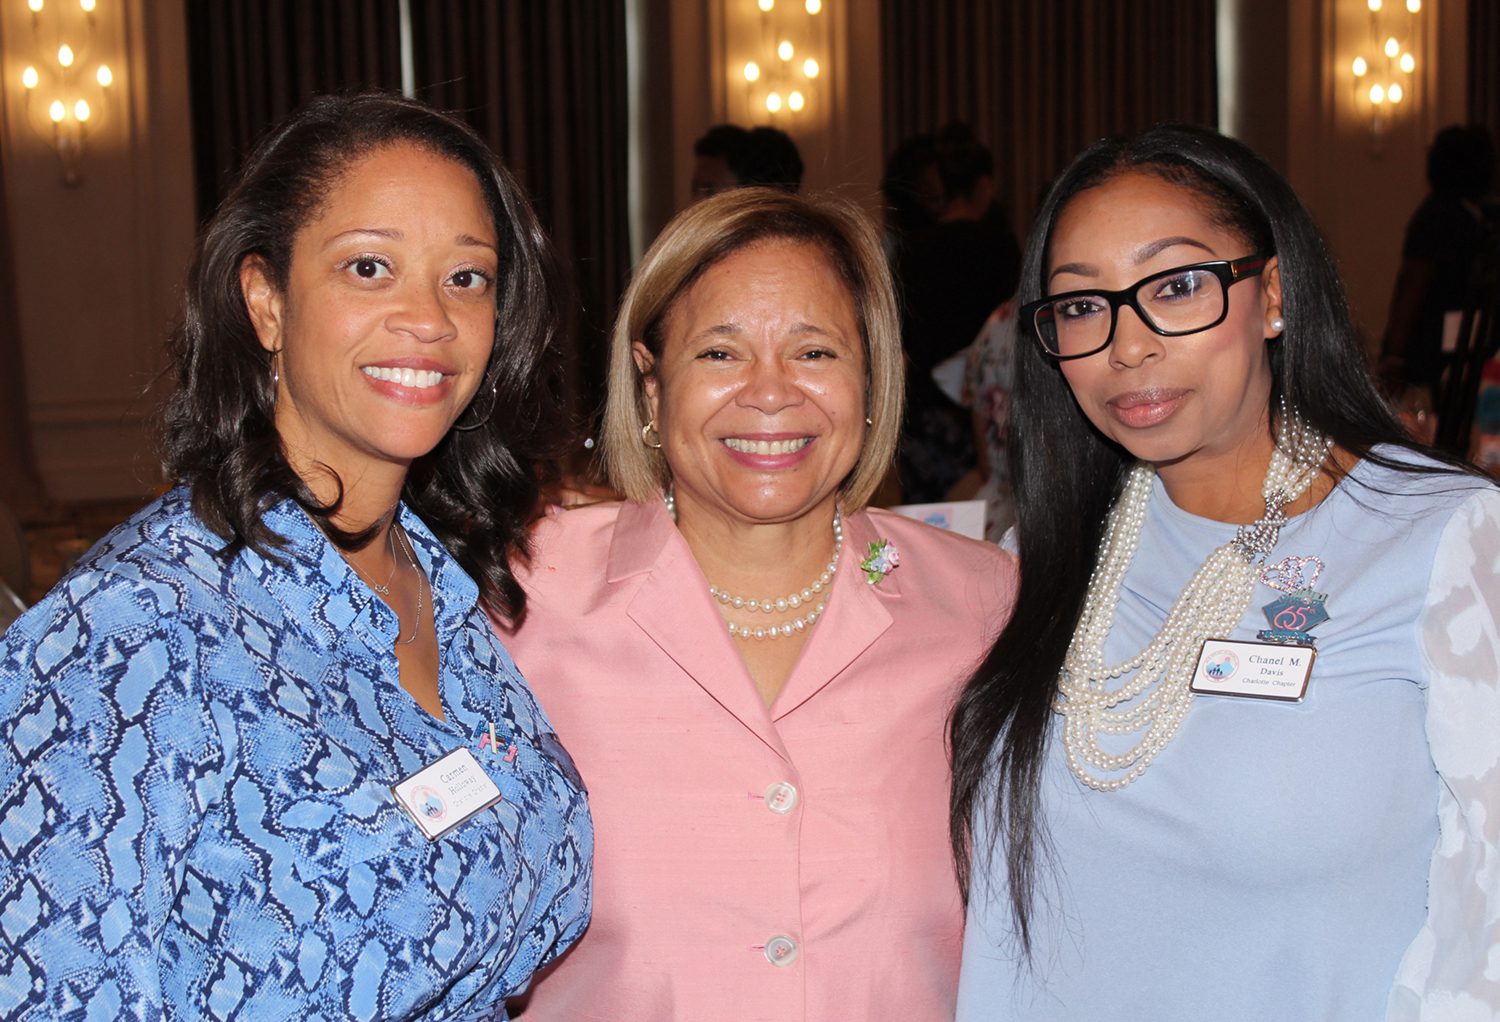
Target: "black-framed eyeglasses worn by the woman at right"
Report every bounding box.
[1020,255,1271,362]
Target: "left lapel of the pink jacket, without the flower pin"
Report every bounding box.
[609,501,792,759]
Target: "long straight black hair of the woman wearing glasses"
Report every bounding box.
[948,125,1464,954]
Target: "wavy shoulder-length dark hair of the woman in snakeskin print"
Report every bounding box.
[162,93,563,617]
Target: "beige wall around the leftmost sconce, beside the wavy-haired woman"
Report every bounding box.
[0,0,194,500]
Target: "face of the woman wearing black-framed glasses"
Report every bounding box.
[1047,171,1281,486]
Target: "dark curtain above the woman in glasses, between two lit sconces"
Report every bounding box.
[881,0,1218,237]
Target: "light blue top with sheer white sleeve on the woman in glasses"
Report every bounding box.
[959,452,1500,1022]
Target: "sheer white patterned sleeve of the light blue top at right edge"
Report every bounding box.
[1386,489,1500,1022]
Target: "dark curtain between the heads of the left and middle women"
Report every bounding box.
[411,0,630,411]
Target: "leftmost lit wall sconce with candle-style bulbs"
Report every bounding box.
[11,0,116,185]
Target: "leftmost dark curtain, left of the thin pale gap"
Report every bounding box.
[186,0,401,218]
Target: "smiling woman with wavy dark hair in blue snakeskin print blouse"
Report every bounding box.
[0,95,593,1019]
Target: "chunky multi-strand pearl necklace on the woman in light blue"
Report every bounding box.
[1055,414,1332,791]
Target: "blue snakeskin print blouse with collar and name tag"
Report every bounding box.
[0,489,593,1020]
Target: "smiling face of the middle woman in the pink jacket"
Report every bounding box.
[635,240,866,524]
